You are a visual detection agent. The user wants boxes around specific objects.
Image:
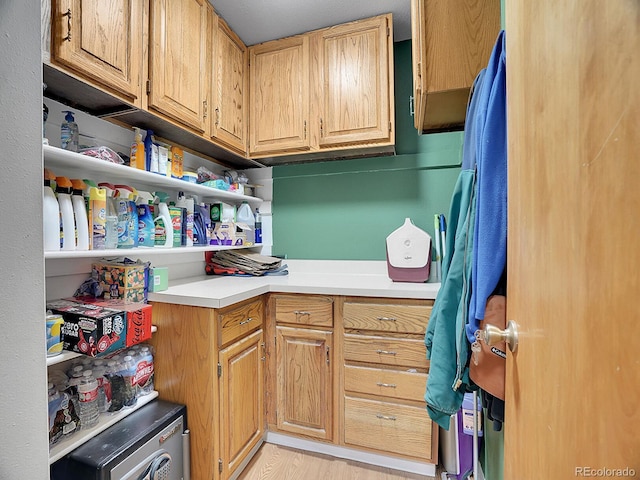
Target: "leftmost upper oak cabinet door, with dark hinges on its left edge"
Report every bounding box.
[52,0,143,105]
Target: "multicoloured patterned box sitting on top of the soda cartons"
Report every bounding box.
[91,262,149,303]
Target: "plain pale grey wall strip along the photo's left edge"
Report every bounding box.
[0,0,49,480]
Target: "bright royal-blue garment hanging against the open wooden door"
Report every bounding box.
[466,31,507,343]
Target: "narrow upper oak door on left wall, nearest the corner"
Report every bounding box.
[211,15,248,155]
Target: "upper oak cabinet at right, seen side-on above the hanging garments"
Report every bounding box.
[411,0,500,132]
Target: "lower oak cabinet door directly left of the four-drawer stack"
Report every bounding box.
[276,326,333,440]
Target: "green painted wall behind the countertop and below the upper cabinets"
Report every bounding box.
[272,41,462,260]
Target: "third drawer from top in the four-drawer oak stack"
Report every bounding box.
[344,365,427,402]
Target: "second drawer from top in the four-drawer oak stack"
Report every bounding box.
[344,333,429,368]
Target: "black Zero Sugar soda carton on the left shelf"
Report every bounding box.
[47,302,127,357]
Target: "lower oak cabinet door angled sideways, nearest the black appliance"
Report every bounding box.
[219,330,265,479]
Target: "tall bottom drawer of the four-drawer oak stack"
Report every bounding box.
[344,397,434,461]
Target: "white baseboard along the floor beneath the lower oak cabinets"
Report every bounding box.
[266,432,436,477]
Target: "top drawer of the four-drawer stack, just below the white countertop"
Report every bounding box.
[343,302,431,334]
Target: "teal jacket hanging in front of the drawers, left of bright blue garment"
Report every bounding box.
[424,71,484,429]
